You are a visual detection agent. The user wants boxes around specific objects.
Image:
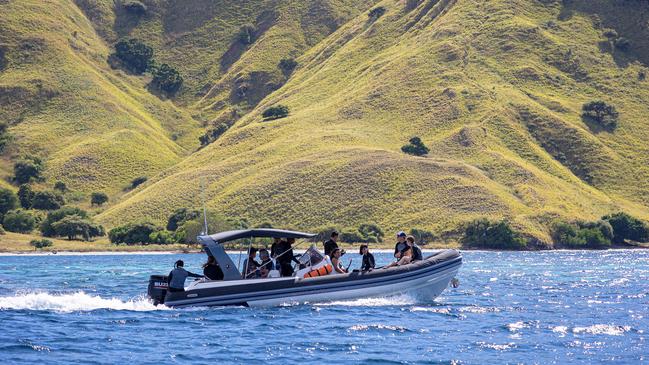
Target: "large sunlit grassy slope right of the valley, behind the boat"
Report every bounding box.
[100,0,649,245]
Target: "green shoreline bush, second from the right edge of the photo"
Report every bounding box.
[550,221,613,248]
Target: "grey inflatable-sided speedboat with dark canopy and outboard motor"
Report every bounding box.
[148,229,462,307]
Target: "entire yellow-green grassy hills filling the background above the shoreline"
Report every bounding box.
[0,0,649,246]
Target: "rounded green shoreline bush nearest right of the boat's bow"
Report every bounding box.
[462,218,527,250]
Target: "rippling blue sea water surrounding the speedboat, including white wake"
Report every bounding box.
[0,250,649,364]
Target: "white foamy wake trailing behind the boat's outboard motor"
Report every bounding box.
[0,291,167,312]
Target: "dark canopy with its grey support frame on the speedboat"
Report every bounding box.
[197,228,316,280]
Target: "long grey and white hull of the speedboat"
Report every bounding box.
[165,250,462,307]
